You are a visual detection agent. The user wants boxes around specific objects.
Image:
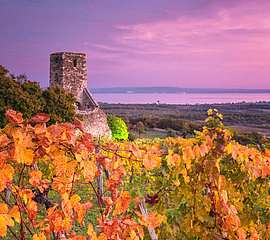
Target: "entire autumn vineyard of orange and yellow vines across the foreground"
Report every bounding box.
[0,109,270,240]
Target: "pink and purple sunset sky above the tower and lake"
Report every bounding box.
[0,0,270,88]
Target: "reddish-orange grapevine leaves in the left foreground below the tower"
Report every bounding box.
[0,110,163,240]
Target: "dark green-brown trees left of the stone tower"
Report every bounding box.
[0,65,75,127]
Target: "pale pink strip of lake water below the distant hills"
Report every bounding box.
[93,93,270,104]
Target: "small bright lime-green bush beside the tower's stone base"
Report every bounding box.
[108,114,128,140]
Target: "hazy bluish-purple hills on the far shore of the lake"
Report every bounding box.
[91,87,270,94]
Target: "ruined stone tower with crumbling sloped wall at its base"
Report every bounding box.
[50,52,111,136]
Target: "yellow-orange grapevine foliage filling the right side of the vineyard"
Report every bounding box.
[102,110,270,240]
